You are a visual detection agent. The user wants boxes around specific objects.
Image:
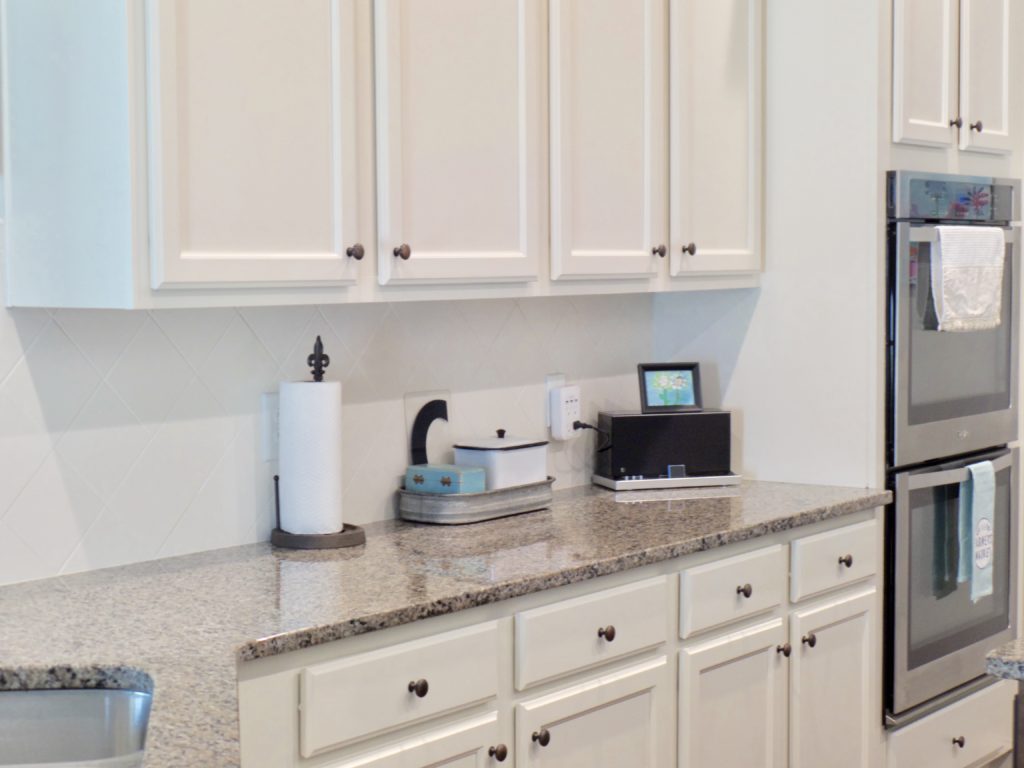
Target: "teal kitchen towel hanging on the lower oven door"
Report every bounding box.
[957,462,995,602]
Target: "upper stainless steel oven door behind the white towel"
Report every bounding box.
[892,224,1018,466]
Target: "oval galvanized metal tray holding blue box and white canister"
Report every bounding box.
[398,477,555,525]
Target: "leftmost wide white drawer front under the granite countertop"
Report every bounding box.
[299,622,499,758]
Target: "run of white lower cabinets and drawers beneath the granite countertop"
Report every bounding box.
[239,515,884,768]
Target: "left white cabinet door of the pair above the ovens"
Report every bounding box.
[893,0,959,146]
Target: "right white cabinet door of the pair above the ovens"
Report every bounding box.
[959,0,1013,153]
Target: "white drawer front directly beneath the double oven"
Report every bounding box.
[889,680,1016,768]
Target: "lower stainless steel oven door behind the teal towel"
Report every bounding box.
[893,449,1017,711]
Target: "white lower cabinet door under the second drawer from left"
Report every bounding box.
[515,656,674,768]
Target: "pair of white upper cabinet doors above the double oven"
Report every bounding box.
[893,0,1013,153]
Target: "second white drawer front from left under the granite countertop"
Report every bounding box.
[515,577,669,690]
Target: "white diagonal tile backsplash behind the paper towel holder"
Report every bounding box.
[0,288,652,584]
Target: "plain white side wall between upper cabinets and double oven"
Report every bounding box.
[654,1,889,486]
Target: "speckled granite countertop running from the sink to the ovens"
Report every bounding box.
[0,482,890,767]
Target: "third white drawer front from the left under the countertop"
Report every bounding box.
[679,545,785,638]
